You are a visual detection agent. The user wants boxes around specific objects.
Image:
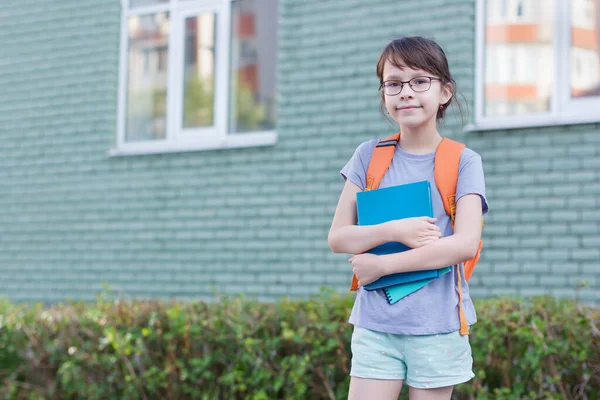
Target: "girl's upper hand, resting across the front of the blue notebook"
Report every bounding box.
[386,217,442,249]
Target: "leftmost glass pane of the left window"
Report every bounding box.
[125,13,169,142]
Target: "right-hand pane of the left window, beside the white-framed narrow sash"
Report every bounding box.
[229,0,278,133]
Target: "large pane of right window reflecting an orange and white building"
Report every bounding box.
[484,0,554,116]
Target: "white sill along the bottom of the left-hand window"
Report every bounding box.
[108,131,277,157]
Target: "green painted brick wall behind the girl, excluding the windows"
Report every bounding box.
[0,0,600,303]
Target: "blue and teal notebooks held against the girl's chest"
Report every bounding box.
[356,181,451,304]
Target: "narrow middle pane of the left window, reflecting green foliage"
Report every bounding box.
[182,13,216,128]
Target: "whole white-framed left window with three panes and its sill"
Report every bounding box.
[111,0,278,155]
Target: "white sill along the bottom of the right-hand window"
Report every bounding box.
[463,112,600,132]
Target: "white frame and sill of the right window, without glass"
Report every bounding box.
[465,0,600,131]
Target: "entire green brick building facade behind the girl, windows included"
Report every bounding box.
[0,0,600,304]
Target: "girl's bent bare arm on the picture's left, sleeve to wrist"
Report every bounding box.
[327,180,391,254]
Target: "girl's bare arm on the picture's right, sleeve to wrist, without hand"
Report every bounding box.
[377,194,482,275]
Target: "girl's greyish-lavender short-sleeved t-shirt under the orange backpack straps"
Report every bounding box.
[340,139,488,335]
